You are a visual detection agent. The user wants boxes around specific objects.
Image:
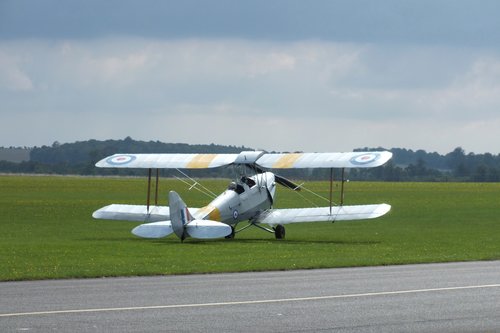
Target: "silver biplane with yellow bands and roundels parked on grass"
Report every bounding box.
[92,151,392,241]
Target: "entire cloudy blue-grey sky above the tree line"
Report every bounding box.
[0,0,500,154]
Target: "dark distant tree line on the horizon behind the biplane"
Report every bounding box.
[0,137,500,182]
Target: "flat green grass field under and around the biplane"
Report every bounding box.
[0,176,500,280]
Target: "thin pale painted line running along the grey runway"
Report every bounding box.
[0,284,500,317]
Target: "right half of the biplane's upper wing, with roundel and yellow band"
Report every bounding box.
[257,151,392,169]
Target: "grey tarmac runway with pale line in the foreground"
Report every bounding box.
[0,261,500,332]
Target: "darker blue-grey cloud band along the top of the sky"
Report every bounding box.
[0,0,500,47]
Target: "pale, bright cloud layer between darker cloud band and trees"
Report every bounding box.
[0,31,500,152]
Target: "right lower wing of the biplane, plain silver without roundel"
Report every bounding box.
[255,204,391,225]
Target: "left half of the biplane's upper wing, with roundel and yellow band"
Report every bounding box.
[96,154,239,169]
